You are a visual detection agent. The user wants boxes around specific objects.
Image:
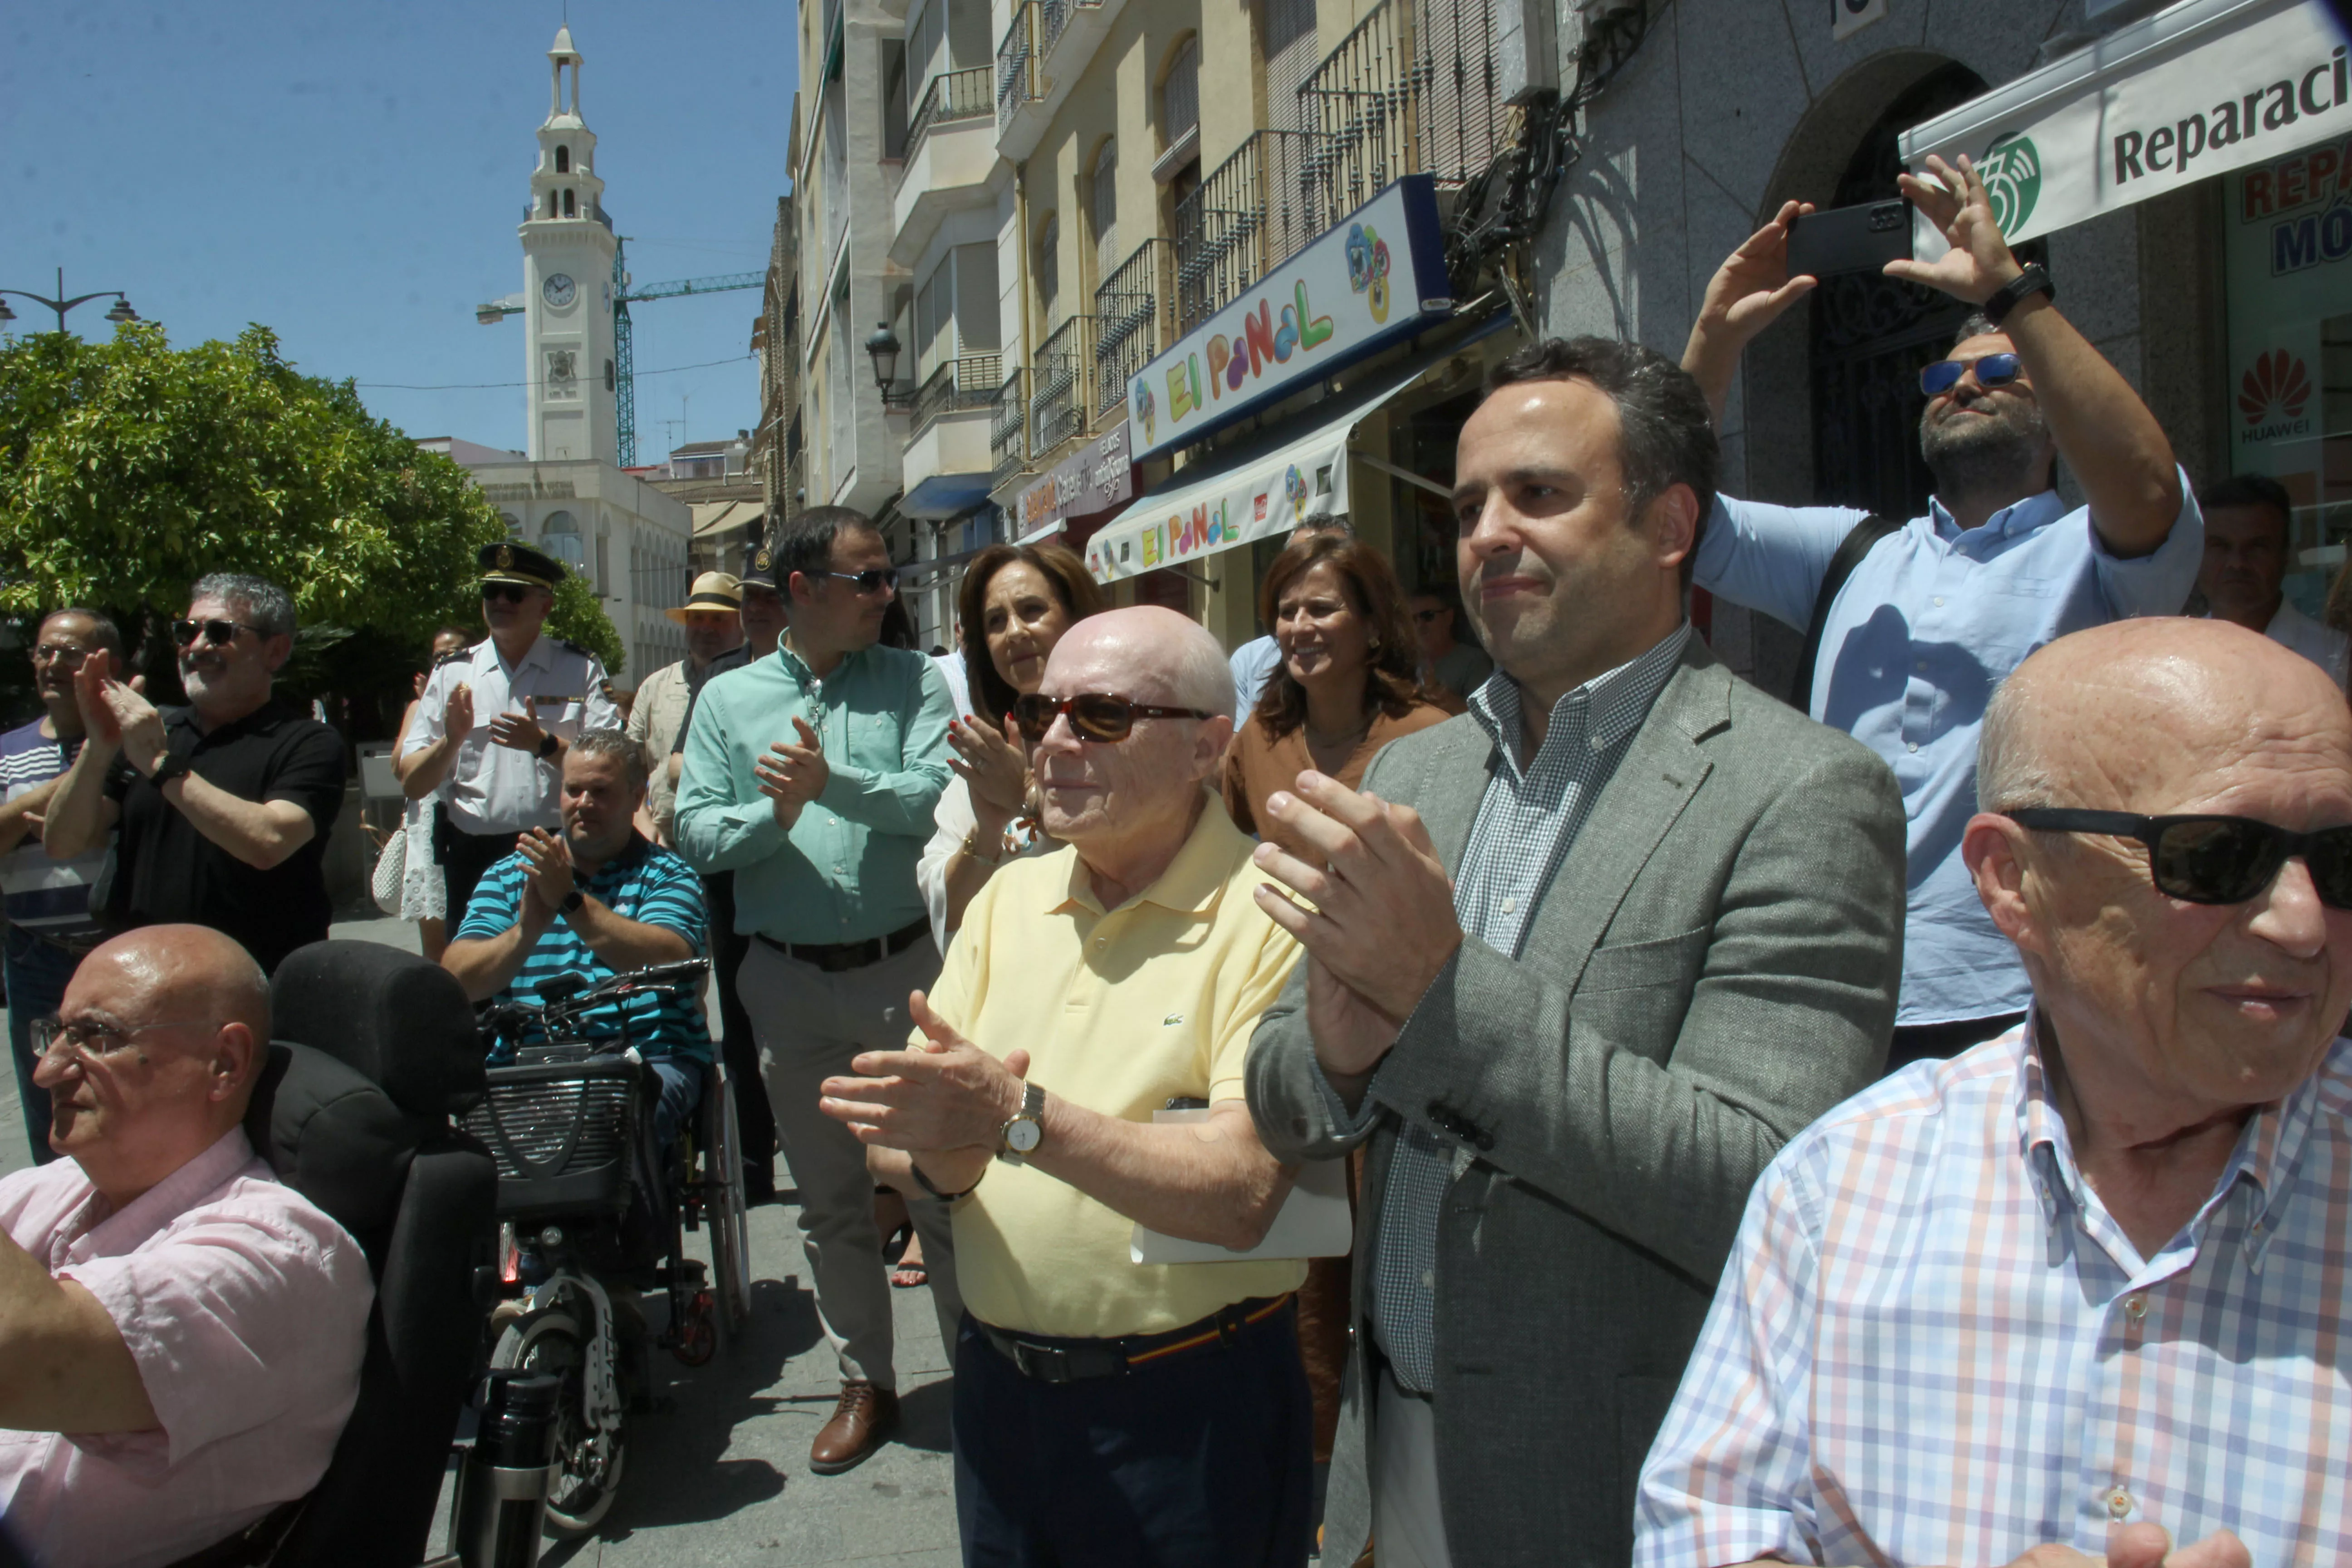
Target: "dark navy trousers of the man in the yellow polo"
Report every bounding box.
[953,1307,1315,1568]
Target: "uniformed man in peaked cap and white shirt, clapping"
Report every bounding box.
[397,541,623,926]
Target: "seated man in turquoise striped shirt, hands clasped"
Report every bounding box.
[442,729,710,1145]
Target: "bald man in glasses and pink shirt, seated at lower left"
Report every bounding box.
[0,926,374,1568]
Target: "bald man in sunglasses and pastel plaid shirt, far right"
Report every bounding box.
[1635,621,2352,1568]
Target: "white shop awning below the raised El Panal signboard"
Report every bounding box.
[1087,310,1510,583]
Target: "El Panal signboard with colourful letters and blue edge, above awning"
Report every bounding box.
[1127,174,1454,458]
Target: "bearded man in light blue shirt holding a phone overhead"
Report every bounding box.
[1682,157,2204,1067]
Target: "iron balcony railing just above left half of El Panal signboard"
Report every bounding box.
[1176,132,1338,332]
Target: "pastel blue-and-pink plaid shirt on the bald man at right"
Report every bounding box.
[1635,1025,2352,1568]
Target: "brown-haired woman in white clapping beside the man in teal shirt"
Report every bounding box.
[915,545,1103,952]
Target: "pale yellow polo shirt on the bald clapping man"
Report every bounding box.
[915,794,1305,1340]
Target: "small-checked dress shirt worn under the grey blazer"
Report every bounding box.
[1324,625,1691,1394]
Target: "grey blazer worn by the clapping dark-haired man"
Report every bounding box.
[1247,639,1903,1568]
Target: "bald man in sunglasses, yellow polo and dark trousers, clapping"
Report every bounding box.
[821,607,1313,1568]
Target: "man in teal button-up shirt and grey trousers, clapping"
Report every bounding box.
[677,505,962,1474]
